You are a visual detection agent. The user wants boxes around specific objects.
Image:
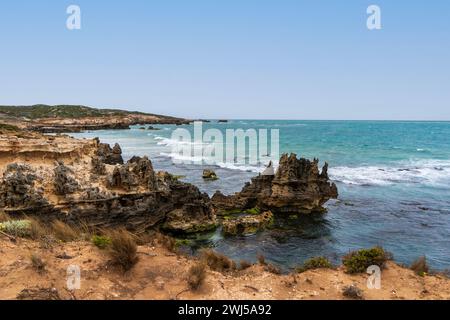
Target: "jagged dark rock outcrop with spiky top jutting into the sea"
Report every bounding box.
[212,154,338,213]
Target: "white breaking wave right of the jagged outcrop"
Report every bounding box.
[329,160,450,187]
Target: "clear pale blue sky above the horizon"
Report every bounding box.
[0,0,450,120]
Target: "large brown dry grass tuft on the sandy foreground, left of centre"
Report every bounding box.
[109,229,138,272]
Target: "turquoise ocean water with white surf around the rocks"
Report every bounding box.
[73,120,450,270]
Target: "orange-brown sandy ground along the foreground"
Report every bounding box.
[0,236,450,300]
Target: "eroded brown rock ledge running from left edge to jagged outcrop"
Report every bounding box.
[0,129,337,233]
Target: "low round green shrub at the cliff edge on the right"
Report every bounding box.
[342,247,392,273]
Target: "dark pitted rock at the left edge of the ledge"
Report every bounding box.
[0,163,47,208]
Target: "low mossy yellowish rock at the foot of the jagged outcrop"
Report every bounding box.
[222,211,273,235]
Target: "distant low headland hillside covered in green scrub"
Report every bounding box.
[0,104,179,120]
